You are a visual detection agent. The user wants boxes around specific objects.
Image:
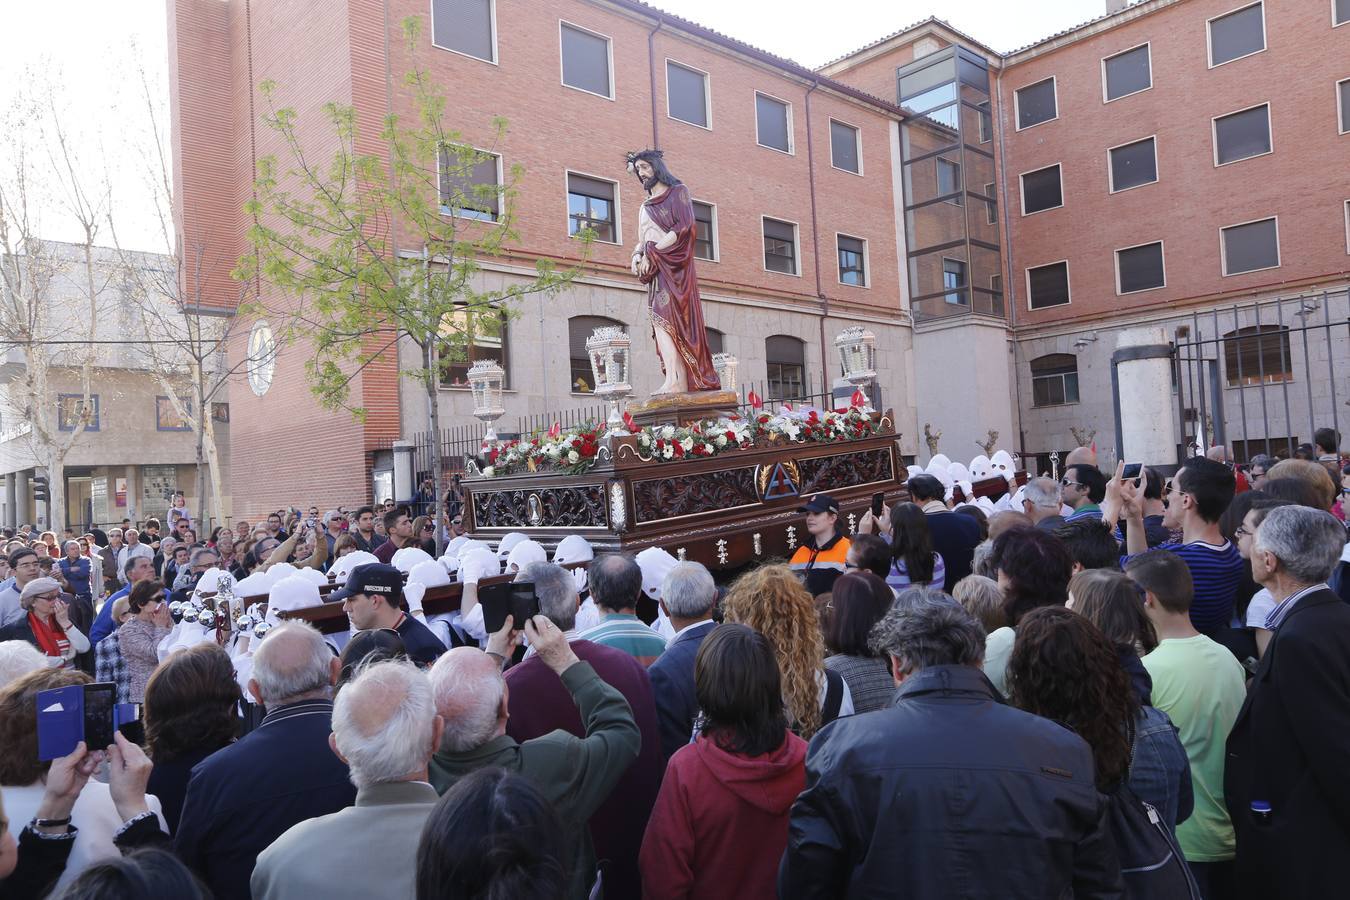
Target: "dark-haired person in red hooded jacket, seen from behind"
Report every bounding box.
[639,625,806,899]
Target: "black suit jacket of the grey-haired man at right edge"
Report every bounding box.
[1223,590,1350,900]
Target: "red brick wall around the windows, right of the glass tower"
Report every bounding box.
[1000,0,1350,324]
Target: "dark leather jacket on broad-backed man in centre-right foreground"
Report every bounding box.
[778,665,1122,900]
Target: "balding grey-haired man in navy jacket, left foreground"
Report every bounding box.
[174,622,356,900]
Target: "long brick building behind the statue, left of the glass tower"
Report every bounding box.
[170,0,918,515]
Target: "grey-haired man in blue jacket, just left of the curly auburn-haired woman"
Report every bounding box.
[647,563,717,761]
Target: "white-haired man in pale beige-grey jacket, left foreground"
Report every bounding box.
[250,661,444,900]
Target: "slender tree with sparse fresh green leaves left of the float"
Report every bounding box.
[235,18,593,545]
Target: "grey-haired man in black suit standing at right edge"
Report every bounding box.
[1223,506,1350,897]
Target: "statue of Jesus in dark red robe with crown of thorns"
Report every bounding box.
[628,150,722,395]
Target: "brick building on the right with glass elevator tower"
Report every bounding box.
[821,0,1350,467]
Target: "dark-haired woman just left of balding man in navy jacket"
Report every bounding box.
[144,641,242,833]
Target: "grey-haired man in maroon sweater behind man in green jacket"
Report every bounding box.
[506,563,664,900]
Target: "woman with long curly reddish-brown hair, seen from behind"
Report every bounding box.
[724,565,853,739]
